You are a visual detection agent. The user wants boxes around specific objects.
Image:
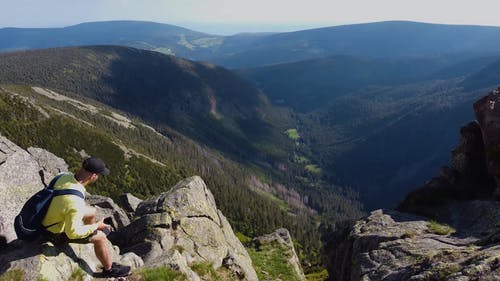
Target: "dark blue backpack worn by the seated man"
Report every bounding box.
[14,174,85,241]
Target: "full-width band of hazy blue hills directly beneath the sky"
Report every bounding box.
[0,21,500,68]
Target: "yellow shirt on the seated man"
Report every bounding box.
[42,173,97,239]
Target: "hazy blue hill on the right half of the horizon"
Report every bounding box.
[212,21,500,68]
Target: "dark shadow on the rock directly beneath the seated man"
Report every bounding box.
[0,240,95,276]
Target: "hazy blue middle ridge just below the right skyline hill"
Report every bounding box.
[237,56,474,112]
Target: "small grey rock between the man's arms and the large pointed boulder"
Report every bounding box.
[85,194,130,230]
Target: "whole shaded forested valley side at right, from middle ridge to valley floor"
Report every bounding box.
[238,56,500,209]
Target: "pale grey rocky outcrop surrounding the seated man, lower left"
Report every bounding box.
[0,136,282,281]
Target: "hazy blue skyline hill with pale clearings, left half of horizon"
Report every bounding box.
[0,21,222,57]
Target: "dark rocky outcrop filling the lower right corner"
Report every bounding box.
[327,90,500,281]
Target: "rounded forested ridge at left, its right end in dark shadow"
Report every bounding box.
[0,46,292,163]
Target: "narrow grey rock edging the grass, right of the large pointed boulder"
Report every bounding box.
[254,228,306,281]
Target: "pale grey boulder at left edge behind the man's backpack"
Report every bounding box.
[0,135,68,243]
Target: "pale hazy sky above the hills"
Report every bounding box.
[0,0,500,35]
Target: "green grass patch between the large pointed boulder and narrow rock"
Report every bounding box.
[247,242,299,281]
